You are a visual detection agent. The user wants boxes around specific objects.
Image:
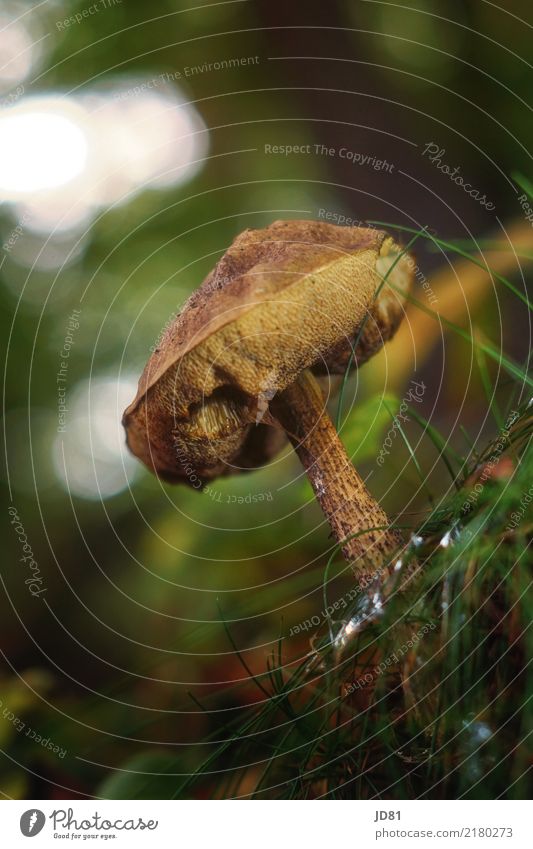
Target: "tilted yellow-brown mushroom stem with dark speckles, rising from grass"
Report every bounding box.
[270,371,402,580]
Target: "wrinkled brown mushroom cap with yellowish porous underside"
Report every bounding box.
[123,221,414,488]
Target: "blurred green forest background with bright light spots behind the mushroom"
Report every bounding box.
[0,0,533,798]
